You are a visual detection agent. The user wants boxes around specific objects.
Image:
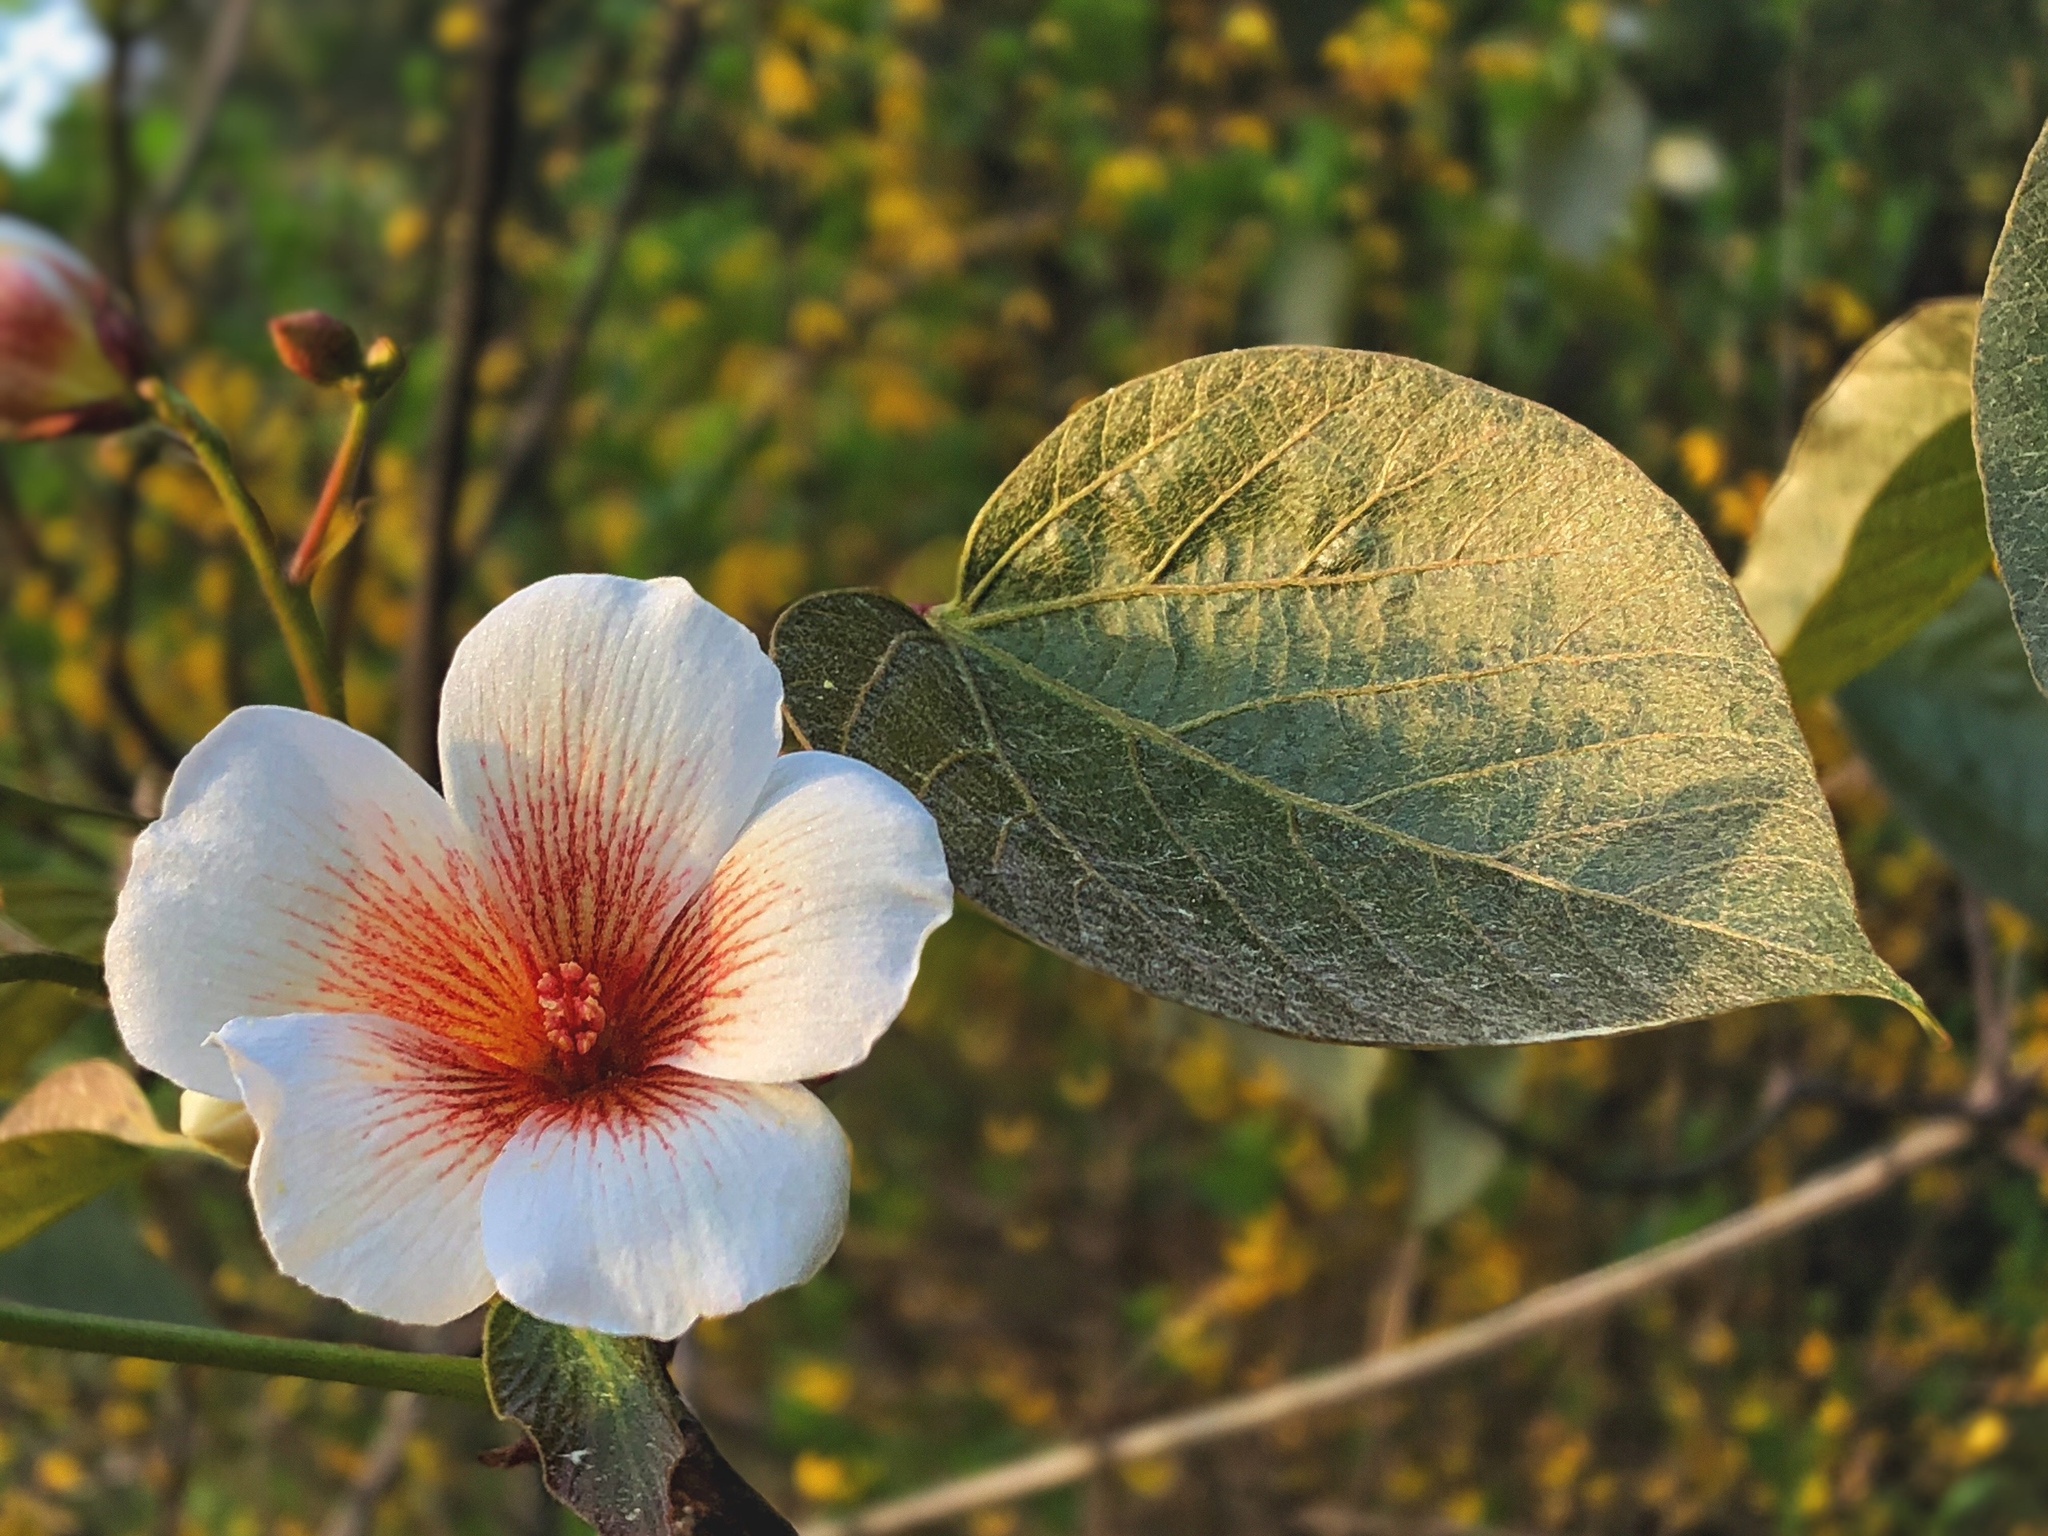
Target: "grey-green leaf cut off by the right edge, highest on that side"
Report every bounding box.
[1974,117,2048,684]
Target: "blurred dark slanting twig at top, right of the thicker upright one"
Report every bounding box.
[475,0,702,545]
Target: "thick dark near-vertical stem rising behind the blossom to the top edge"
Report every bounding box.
[399,0,532,776]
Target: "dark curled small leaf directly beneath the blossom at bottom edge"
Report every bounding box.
[483,1300,795,1536]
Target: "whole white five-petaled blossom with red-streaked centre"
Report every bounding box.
[106,575,952,1337]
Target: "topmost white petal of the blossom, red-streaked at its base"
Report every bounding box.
[440,575,782,997]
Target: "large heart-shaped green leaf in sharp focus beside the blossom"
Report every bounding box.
[774,348,1917,1044]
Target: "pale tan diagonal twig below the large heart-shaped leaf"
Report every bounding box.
[803,1118,1976,1536]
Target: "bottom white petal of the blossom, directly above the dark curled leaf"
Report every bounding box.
[483,1067,850,1339]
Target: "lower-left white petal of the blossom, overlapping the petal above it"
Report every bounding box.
[219,1014,535,1323]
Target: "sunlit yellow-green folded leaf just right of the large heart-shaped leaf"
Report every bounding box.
[1735,299,1991,698]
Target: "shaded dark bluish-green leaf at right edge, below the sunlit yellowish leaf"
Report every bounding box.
[1835,575,2048,922]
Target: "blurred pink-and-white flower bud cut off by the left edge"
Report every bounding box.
[0,213,147,438]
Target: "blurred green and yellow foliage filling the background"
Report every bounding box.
[0,0,2048,1536]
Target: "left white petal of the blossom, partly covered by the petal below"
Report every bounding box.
[106,707,547,1098]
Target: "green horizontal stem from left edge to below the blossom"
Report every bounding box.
[0,1303,489,1407]
